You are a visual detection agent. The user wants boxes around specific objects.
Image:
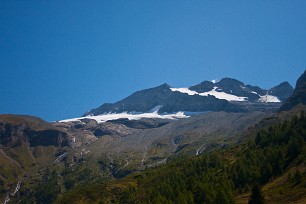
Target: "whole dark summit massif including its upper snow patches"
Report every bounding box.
[83,78,293,117]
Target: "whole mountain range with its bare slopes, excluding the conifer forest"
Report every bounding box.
[0,72,306,203]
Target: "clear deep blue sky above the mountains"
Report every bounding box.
[0,0,306,121]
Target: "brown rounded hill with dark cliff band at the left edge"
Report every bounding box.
[0,115,71,200]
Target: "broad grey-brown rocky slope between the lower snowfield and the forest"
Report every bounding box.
[50,112,271,183]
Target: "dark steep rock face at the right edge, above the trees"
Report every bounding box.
[280,71,306,111]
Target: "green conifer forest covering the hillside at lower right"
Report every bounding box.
[59,112,306,204]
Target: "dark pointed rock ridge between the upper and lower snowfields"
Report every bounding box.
[86,84,242,115]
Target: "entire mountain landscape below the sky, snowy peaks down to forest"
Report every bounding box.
[0,73,306,203]
